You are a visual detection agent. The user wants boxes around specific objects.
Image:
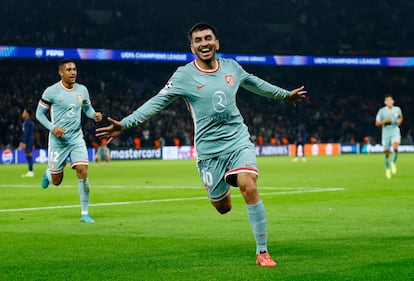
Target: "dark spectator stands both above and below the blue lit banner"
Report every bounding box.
[0,0,414,148]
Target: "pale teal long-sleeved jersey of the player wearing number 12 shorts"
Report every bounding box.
[36,81,95,143]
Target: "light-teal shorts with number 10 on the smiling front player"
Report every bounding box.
[197,145,259,202]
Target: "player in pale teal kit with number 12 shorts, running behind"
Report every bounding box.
[36,59,102,223]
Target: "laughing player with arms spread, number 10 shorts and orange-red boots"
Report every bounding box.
[96,23,306,266]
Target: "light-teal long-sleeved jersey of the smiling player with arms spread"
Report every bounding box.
[121,59,289,159]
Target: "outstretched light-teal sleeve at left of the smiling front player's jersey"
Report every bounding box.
[121,68,183,129]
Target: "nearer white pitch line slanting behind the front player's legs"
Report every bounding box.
[0,188,345,213]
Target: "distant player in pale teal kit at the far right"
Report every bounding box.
[375,95,403,179]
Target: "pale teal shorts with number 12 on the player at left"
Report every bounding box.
[48,138,89,174]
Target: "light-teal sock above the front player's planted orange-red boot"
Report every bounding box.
[247,200,267,254]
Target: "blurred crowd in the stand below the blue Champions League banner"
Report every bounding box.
[0,60,414,147]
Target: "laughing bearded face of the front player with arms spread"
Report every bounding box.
[191,29,220,63]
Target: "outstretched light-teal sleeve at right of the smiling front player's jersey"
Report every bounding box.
[234,62,289,100]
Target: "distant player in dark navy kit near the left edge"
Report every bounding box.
[19,108,34,178]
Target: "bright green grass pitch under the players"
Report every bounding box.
[0,154,414,281]
